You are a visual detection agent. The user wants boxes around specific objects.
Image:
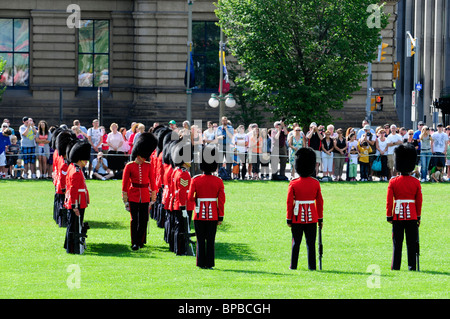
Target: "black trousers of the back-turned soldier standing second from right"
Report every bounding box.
[289,223,317,270]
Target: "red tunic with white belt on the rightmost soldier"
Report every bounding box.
[386,175,422,221]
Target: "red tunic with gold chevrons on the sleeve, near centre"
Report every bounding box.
[171,167,194,210]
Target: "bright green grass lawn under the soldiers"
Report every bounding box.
[0,180,450,299]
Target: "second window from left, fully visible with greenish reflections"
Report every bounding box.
[78,20,109,88]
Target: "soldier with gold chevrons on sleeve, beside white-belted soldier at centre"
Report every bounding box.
[170,140,194,256]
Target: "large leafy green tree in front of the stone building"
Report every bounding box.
[216,0,388,127]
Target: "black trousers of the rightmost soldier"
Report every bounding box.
[391,220,419,270]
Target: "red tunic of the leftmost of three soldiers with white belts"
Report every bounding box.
[188,174,225,221]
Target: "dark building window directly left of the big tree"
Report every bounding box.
[192,21,220,92]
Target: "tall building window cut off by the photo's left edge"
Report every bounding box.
[0,19,30,88]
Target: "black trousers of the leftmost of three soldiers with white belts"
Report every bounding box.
[194,220,217,268]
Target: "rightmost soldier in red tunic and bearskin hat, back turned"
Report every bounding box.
[386,144,422,270]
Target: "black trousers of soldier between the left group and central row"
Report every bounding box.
[130,202,150,247]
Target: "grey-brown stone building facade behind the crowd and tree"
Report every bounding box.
[0,0,398,127]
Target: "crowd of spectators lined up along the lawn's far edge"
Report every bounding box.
[0,117,450,182]
